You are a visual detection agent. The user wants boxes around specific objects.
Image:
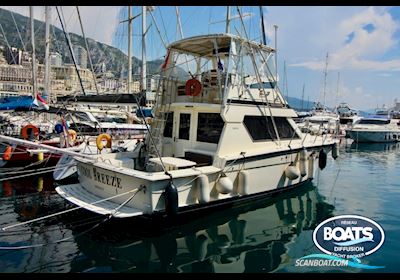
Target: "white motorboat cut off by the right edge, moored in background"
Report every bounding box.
[346,118,400,143]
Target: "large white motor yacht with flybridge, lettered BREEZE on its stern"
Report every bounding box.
[56,7,337,218]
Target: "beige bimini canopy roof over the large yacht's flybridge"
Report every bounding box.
[168,34,275,56]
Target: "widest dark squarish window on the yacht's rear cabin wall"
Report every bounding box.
[197,113,224,144]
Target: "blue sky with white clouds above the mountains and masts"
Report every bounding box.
[1,6,400,110]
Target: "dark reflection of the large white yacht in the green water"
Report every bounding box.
[67,184,334,272]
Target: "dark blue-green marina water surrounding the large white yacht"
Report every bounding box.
[0,140,400,273]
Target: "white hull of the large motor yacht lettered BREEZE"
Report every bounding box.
[56,145,331,218]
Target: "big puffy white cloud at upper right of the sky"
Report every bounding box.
[290,7,400,71]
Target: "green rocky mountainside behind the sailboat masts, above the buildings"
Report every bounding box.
[0,8,163,77]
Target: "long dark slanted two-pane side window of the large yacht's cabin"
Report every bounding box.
[243,116,299,141]
